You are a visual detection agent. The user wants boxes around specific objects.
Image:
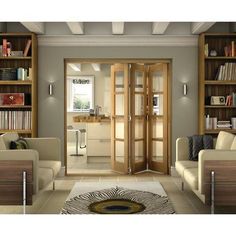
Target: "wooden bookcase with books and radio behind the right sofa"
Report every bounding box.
[199,33,236,135]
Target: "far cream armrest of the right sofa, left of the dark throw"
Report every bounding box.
[176,137,189,161]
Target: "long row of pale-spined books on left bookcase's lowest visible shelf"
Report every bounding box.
[0,111,31,130]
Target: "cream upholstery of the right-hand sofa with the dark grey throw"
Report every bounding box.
[175,131,236,203]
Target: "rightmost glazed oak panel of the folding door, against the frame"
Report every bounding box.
[148,63,168,173]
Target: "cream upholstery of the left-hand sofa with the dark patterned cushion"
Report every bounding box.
[0,133,61,194]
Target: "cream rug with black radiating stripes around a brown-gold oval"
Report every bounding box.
[61,182,175,214]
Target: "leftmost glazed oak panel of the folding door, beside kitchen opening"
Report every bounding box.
[111,64,129,174]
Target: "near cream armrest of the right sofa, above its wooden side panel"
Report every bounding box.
[198,149,236,194]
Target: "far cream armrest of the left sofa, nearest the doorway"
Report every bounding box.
[26,138,61,161]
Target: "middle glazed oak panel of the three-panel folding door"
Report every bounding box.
[130,64,147,173]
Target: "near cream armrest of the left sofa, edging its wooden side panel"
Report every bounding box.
[0,149,39,194]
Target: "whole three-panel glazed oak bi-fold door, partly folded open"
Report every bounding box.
[111,63,168,173]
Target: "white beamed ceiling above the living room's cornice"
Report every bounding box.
[4,22,227,36]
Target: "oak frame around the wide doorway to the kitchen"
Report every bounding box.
[64,58,172,176]
